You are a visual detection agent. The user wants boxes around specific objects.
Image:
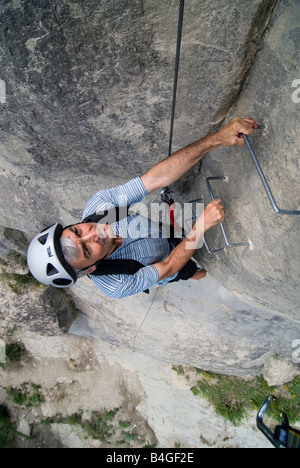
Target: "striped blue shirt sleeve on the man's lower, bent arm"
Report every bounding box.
[90,265,158,299]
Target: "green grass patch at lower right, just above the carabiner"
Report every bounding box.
[173,366,300,426]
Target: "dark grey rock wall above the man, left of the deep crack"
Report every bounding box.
[1,0,282,229]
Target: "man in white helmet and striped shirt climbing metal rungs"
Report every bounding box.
[27,118,257,298]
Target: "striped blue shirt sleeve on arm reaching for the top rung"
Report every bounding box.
[82,177,147,219]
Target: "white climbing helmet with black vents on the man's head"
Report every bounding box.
[27,224,77,289]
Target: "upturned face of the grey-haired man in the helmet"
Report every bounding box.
[62,223,116,269]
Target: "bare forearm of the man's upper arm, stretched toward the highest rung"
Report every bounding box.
[141,133,220,193]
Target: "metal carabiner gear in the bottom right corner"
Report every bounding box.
[256,395,300,448]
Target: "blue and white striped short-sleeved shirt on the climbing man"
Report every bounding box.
[82,177,176,298]
